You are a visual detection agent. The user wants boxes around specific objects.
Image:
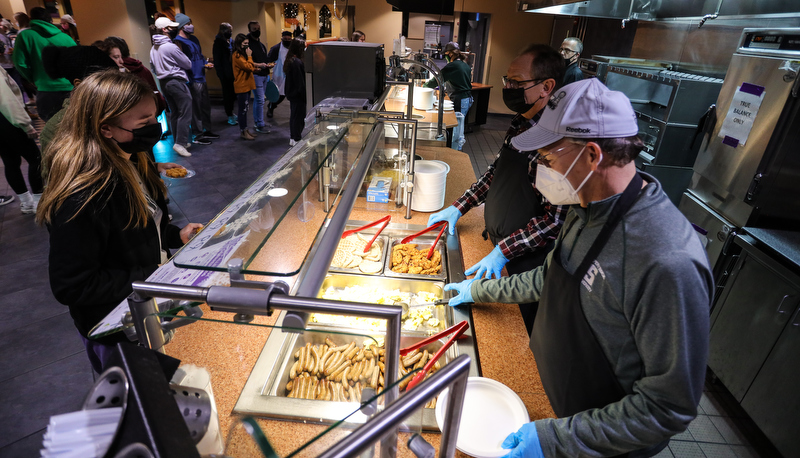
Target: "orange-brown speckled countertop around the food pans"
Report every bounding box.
[166,147,554,457]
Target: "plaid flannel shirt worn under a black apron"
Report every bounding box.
[453,114,569,259]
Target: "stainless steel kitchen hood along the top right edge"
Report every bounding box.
[517,0,800,20]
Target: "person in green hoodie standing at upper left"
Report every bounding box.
[14,6,76,121]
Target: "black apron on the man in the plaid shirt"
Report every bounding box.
[483,145,544,245]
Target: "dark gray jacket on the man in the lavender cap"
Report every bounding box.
[471,174,713,457]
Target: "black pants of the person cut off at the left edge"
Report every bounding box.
[0,115,42,194]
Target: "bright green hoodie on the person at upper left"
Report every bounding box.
[14,19,76,92]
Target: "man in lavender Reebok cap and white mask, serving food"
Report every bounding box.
[445,78,714,457]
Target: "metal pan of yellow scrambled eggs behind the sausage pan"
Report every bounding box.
[309,274,449,335]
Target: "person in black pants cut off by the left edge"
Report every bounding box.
[0,67,43,215]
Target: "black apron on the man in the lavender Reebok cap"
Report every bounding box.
[530,173,669,457]
